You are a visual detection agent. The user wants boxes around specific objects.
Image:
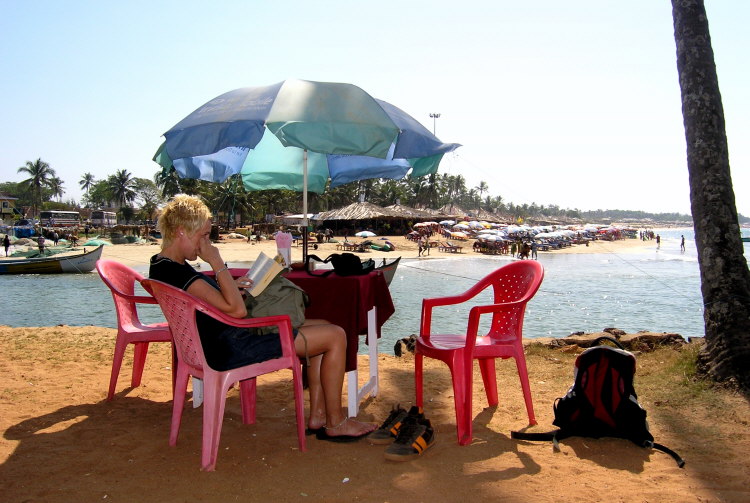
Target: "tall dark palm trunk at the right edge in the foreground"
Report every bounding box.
[672,0,750,391]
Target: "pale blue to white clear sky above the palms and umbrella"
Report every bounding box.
[0,0,750,216]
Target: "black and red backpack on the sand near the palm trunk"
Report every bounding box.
[511,337,685,468]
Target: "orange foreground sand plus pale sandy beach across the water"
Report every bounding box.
[0,234,750,502]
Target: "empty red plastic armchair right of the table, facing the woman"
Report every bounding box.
[414,260,544,445]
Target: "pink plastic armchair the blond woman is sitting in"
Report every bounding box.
[142,280,307,471]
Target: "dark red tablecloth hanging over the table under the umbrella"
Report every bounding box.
[285,271,395,372]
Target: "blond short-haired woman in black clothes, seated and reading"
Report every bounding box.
[149,194,377,441]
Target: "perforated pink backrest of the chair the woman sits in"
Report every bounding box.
[142,279,210,369]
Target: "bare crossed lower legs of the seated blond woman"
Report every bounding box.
[294,320,377,436]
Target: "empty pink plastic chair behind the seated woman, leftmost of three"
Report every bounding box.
[96,260,176,400]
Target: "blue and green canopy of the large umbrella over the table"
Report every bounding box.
[154,80,459,193]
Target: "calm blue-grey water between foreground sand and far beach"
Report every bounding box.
[0,229,750,353]
